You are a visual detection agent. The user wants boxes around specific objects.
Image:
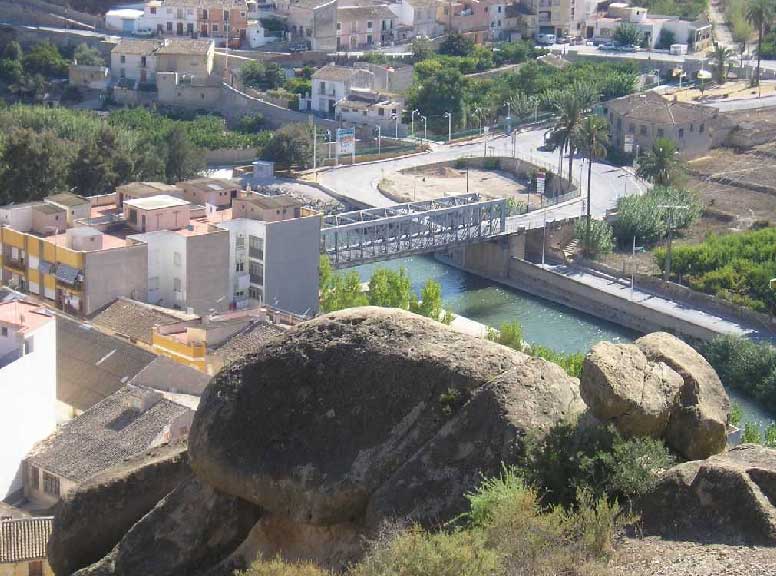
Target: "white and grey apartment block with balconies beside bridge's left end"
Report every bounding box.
[219,207,321,315]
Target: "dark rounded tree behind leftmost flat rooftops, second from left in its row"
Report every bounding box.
[68,128,133,196]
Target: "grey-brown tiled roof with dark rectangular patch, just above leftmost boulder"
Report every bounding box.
[27,386,191,482]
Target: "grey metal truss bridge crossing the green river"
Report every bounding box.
[321,194,508,268]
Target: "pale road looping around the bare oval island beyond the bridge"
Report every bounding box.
[318,130,646,228]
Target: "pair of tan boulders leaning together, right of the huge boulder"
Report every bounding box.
[580,332,730,459]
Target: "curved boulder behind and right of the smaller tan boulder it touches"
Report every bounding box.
[636,332,730,460]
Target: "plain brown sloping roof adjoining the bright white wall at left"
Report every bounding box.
[57,316,156,411]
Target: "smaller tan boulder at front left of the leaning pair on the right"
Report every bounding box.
[580,342,682,438]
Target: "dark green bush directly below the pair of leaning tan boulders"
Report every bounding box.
[522,423,674,506]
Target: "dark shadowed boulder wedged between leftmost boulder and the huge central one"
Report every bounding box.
[75,478,261,576]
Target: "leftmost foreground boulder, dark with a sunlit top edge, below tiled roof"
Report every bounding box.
[48,444,191,576]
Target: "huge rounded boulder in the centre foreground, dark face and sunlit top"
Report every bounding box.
[189,307,584,564]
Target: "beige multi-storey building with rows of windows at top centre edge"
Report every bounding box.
[337,5,398,50]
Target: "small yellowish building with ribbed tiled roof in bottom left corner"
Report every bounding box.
[0,517,54,576]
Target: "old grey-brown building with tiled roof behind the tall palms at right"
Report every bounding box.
[604,92,718,158]
